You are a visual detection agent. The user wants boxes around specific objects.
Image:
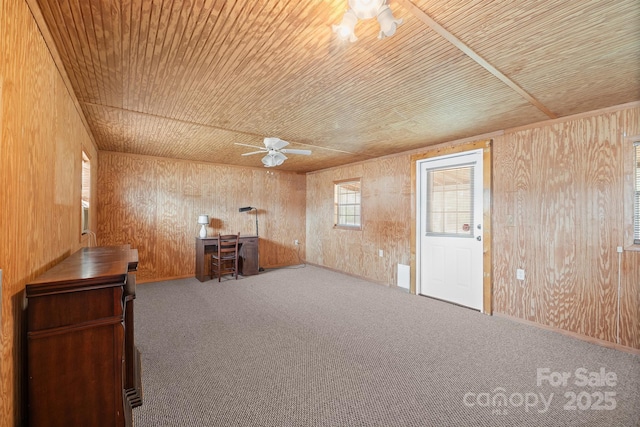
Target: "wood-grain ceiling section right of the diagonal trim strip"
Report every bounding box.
[414,0,640,116]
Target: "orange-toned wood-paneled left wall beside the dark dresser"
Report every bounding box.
[0,0,97,427]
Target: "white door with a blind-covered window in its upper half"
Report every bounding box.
[416,150,483,311]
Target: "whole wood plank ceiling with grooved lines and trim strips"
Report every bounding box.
[28,0,640,173]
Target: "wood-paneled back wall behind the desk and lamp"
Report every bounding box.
[97,151,306,282]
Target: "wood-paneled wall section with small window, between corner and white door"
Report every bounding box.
[307,155,411,286]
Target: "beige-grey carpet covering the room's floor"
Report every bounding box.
[133,266,640,427]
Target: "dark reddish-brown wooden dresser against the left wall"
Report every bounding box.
[26,245,142,427]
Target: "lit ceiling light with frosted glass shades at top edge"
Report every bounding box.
[333,0,402,42]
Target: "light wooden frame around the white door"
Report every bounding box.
[409,139,493,314]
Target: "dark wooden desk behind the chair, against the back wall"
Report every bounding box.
[196,236,260,282]
